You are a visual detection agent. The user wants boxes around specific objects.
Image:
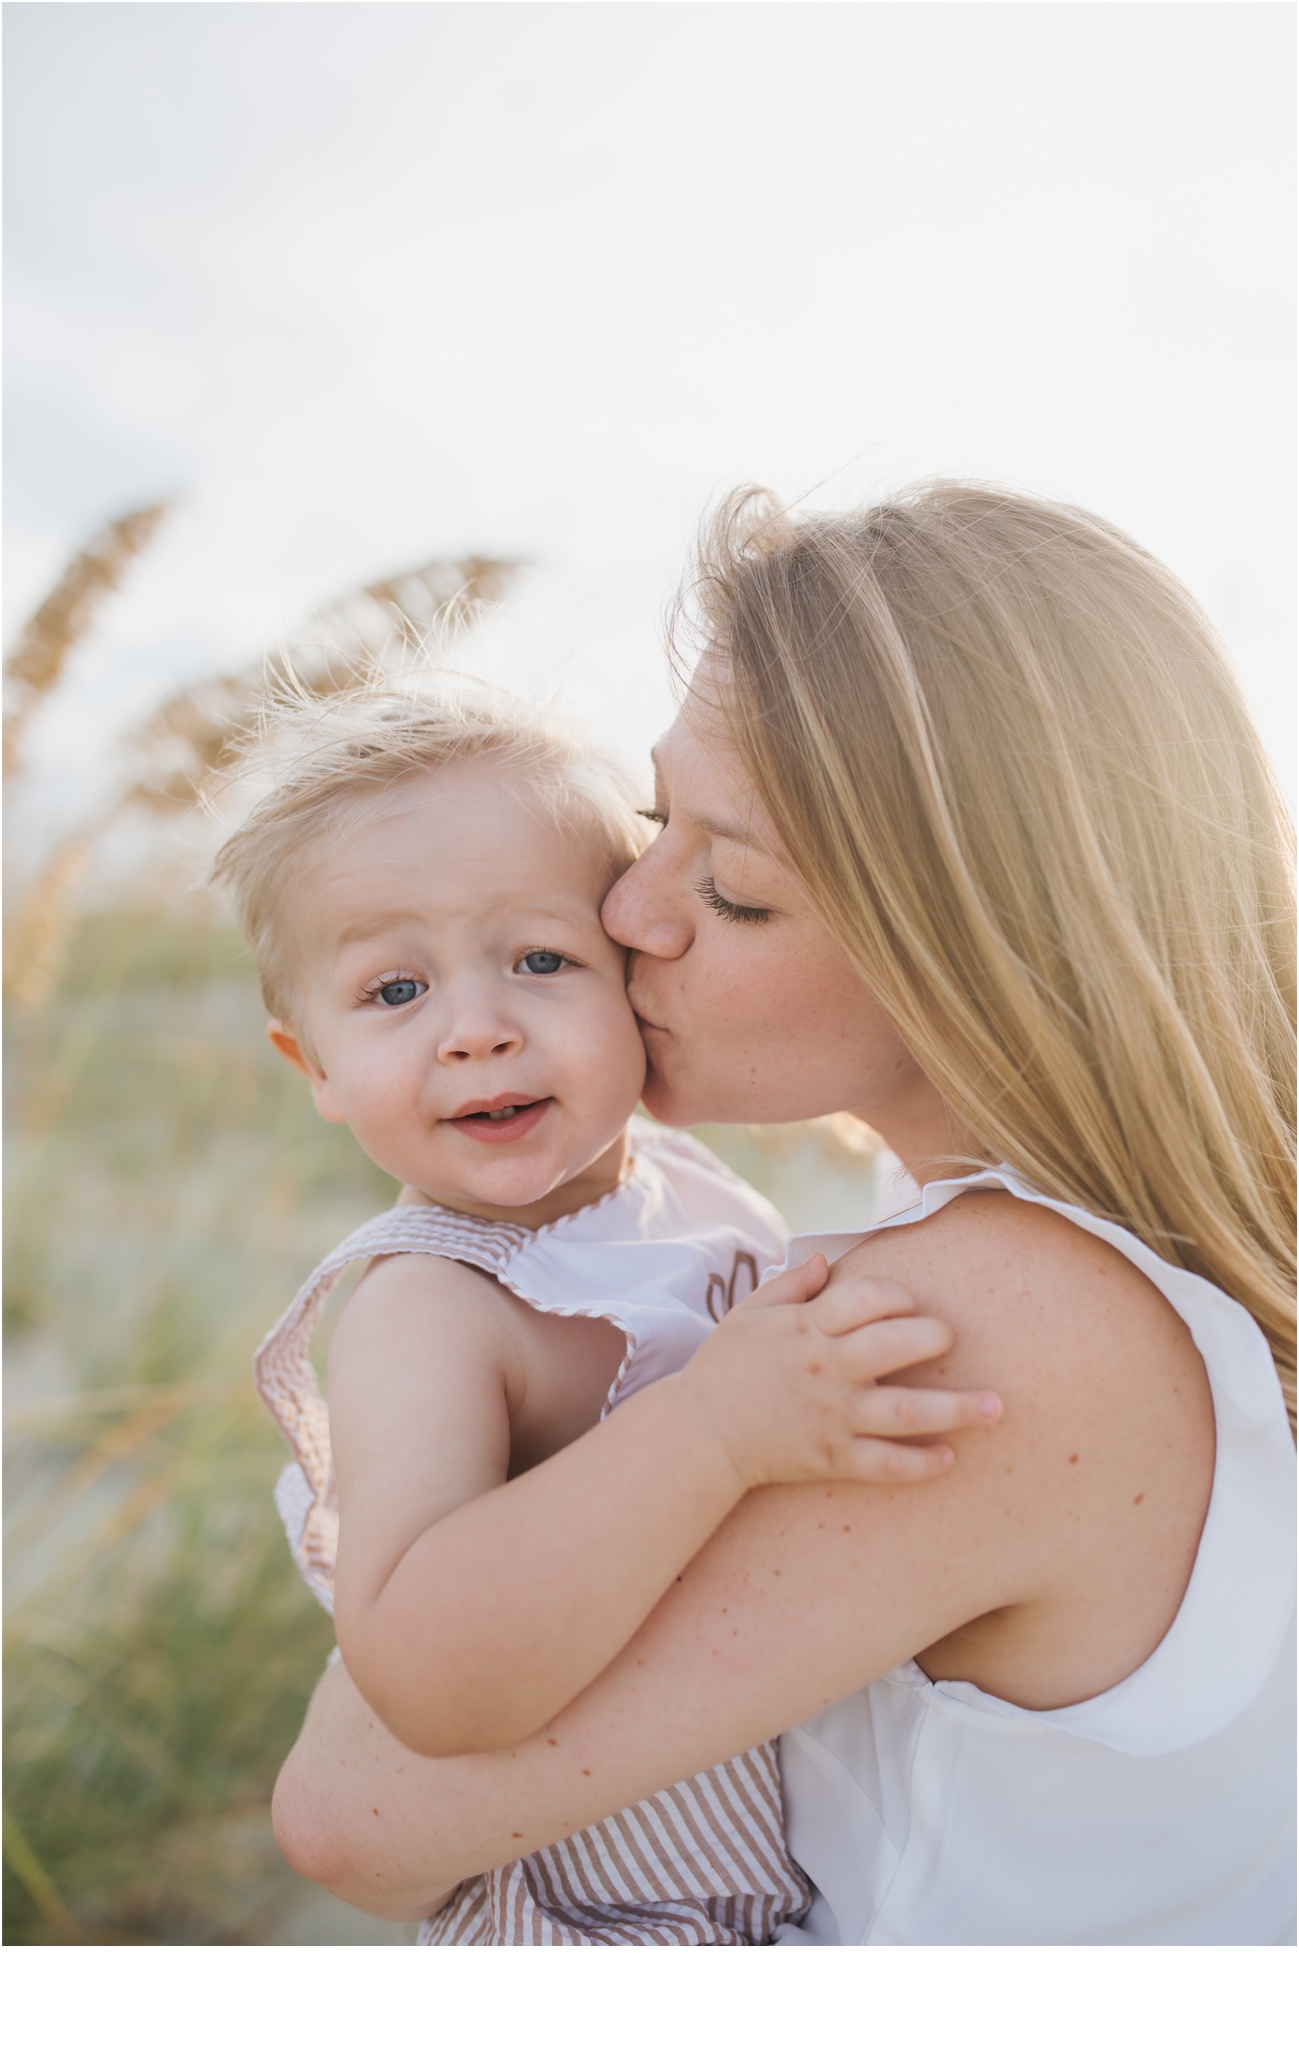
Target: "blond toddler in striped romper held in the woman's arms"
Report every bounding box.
[215,688,981,1946]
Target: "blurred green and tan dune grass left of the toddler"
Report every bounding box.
[4,915,391,1944]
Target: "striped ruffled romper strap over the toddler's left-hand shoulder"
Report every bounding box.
[252,1202,533,1614]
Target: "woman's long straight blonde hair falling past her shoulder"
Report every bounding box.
[690,483,1295,1417]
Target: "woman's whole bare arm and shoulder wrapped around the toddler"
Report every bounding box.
[275,1194,1213,1917]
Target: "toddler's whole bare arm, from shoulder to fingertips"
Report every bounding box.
[330,1255,1000,1755]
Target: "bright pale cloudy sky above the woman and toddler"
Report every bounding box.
[4,0,1295,847]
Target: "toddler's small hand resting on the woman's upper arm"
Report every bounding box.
[680,1251,1002,1487]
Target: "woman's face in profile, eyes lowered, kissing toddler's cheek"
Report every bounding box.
[602,666,947,1157]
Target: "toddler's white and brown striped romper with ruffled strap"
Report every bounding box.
[256,1118,811,1948]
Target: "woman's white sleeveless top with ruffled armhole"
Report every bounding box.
[762,1167,1295,1948]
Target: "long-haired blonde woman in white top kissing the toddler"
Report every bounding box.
[277,485,1295,1946]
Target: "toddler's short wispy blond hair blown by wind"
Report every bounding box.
[211,674,647,1022]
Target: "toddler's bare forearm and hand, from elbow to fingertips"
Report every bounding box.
[327,1262,996,1755]
